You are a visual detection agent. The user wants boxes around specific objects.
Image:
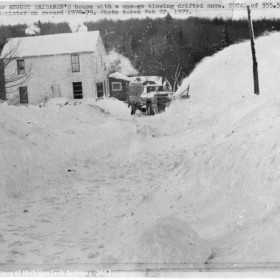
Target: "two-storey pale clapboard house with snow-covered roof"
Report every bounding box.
[2,31,109,104]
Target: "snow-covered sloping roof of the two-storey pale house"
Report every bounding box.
[1,31,99,57]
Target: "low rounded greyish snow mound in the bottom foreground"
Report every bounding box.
[119,216,212,264]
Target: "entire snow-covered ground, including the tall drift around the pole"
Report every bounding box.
[0,33,280,269]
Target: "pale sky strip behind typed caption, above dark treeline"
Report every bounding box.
[0,0,280,24]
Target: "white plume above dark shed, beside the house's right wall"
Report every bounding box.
[106,50,138,76]
